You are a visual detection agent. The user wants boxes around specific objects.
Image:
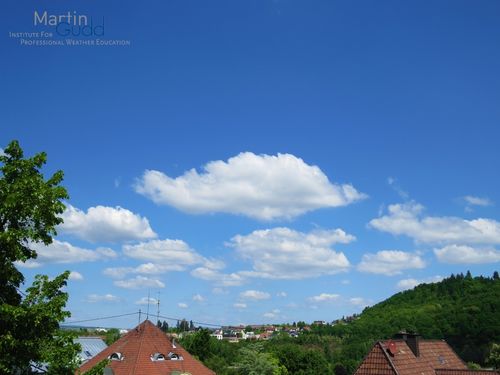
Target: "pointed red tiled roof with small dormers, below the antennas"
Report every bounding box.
[80,320,215,375]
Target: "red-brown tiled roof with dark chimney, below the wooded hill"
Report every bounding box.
[354,332,500,375]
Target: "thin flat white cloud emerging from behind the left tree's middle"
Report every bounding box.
[16,240,117,268]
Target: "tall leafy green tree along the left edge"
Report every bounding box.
[0,141,79,374]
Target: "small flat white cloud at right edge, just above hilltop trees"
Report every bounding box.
[434,245,500,264]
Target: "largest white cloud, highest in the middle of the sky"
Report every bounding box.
[135,152,366,220]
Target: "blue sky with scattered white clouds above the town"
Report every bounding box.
[0,0,500,327]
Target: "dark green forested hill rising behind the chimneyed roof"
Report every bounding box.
[333,272,500,365]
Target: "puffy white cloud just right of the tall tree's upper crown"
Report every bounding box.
[59,205,156,242]
